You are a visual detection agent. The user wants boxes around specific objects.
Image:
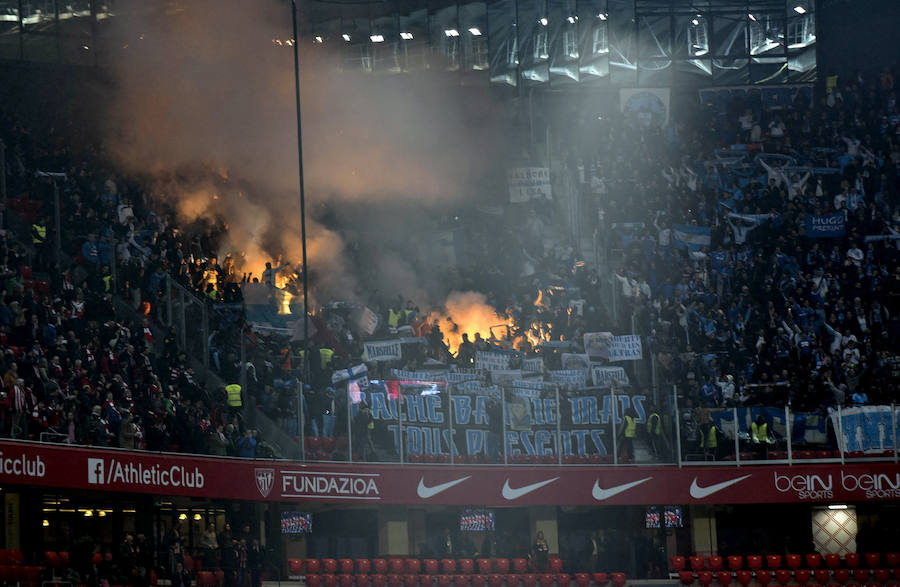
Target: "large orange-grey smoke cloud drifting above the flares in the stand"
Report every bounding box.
[106,0,504,303]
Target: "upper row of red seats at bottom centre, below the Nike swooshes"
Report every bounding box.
[296,557,563,575]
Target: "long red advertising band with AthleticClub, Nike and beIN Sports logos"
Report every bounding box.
[0,441,900,506]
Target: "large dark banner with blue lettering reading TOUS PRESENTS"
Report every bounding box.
[359,380,646,457]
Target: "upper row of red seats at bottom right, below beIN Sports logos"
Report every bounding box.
[670,552,900,573]
